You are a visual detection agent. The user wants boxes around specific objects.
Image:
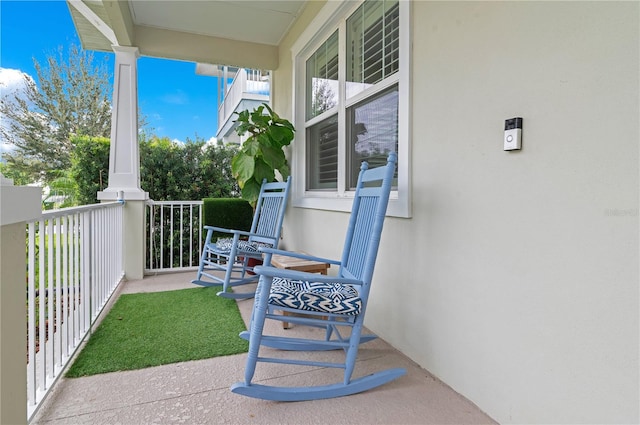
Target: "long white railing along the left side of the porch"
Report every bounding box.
[26,201,124,418]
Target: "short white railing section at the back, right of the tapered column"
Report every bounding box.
[145,201,203,273]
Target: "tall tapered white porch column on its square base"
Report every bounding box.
[98,46,149,280]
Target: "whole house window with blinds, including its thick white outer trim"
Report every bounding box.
[292,0,413,217]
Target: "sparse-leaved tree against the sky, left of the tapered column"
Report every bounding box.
[0,45,112,184]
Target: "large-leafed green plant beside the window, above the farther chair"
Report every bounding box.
[231,103,295,205]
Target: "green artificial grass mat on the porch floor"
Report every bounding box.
[66,287,248,377]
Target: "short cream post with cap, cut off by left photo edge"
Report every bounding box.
[0,174,42,424]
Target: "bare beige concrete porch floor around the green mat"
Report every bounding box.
[31,272,495,425]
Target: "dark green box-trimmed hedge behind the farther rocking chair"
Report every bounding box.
[202,198,253,239]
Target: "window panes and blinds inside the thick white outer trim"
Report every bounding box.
[304,0,400,192]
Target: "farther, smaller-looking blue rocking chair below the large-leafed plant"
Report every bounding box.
[191,177,291,299]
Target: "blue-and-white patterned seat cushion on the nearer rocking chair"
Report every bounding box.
[269,277,362,316]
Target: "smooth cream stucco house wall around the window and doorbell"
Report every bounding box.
[274,2,640,423]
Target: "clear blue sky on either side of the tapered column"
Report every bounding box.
[0,0,218,141]
